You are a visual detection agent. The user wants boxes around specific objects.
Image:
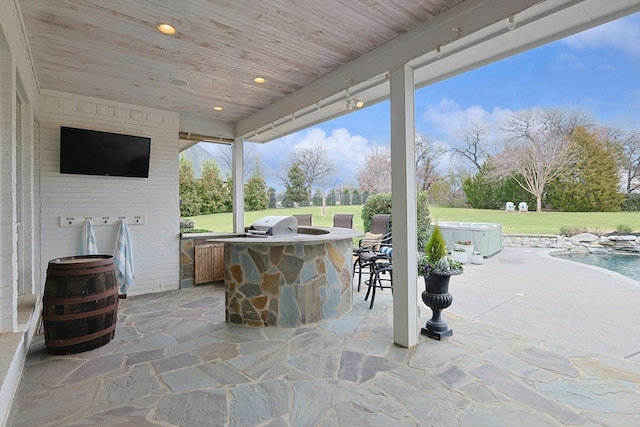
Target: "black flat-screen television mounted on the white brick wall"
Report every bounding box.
[60,126,151,178]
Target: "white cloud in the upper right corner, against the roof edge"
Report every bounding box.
[562,14,640,57]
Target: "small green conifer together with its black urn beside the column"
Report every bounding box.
[418,225,463,340]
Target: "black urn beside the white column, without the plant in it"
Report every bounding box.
[421,273,453,340]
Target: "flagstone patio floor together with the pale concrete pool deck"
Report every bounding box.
[9,248,640,427]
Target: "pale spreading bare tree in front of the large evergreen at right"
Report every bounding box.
[495,110,588,212]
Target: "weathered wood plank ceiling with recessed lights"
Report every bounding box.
[18,0,463,123]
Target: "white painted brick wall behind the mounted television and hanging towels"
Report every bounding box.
[36,91,180,295]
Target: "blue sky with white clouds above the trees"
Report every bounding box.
[215,13,640,191]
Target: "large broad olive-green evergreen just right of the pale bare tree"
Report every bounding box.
[549,126,624,212]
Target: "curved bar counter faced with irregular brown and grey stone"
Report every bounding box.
[208,227,362,328]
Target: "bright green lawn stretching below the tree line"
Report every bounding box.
[186,206,640,234]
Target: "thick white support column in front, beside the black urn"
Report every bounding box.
[390,65,419,348]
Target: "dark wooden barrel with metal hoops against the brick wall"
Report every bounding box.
[42,255,118,354]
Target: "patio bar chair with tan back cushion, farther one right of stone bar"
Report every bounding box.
[353,214,391,292]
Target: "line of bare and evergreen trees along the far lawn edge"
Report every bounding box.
[180,105,640,216]
